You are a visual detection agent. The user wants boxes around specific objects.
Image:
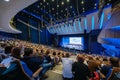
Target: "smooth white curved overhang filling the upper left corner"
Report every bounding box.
[0,0,37,33]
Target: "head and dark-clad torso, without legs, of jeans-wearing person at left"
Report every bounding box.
[21,48,43,72]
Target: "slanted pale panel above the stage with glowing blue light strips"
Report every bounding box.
[48,7,111,35]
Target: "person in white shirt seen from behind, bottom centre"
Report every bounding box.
[62,53,74,80]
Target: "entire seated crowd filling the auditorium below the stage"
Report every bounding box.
[0,39,120,80]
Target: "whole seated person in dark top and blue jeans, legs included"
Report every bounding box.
[22,48,52,77]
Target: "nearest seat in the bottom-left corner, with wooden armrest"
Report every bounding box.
[0,60,42,80]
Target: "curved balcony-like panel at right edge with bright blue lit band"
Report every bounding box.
[98,4,120,43]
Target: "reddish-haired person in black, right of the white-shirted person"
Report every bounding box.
[72,55,90,80]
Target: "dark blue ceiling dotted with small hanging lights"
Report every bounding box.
[14,0,111,27]
